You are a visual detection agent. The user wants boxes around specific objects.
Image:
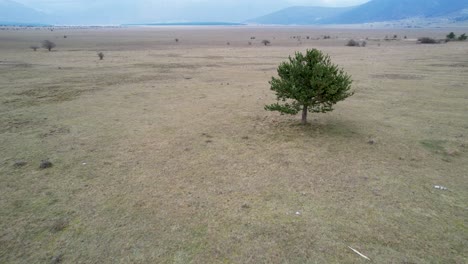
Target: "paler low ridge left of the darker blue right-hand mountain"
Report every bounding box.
[246,6,354,25]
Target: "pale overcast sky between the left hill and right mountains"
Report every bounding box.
[14,0,369,23]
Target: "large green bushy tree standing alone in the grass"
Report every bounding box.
[265,49,354,124]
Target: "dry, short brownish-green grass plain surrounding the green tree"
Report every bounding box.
[0,27,468,263]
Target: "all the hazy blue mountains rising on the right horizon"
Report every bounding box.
[248,0,468,25]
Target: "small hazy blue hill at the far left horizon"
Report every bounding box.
[0,0,47,25]
